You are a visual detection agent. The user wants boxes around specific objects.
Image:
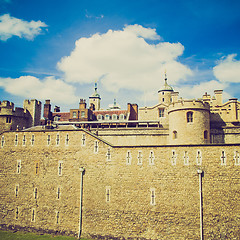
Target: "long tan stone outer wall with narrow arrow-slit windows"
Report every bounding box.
[0,130,240,239]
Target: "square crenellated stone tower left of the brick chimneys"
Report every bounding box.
[23,99,42,126]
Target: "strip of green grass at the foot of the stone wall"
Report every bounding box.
[0,231,76,240]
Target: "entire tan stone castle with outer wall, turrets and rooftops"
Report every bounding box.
[0,76,240,239]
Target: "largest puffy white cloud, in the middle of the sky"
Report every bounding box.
[58,25,192,92]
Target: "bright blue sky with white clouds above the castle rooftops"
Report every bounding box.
[0,0,240,111]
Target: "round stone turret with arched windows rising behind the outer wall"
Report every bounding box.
[168,100,210,144]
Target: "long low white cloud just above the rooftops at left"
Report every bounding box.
[0,76,77,104]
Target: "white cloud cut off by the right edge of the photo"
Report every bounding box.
[213,54,240,83]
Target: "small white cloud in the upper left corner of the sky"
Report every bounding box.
[0,14,47,41]
